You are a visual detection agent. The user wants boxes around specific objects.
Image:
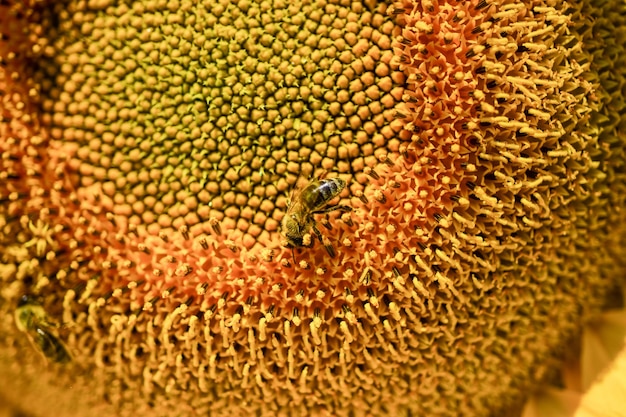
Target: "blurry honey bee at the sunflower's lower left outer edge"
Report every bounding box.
[15,295,71,363]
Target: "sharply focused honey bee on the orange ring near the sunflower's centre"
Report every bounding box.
[281,177,352,262]
